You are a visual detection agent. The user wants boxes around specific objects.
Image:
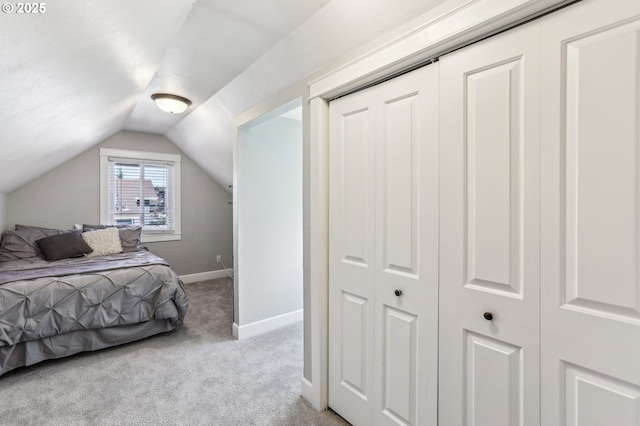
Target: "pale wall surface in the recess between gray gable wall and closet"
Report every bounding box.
[235,118,303,326]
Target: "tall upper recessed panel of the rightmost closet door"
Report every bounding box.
[561,20,640,318]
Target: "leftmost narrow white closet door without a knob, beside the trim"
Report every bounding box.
[329,87,375,424]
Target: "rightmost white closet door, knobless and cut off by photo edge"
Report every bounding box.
[541,0,640,426]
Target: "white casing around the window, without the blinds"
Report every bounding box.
[100,148,182,243]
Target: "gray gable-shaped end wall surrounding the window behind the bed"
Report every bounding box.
[6,131,233,275]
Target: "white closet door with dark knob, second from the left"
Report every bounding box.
[370,64,439,426]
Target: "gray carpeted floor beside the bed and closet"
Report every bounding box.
[0,279,347,426]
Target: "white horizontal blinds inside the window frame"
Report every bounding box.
[107,157,176,234]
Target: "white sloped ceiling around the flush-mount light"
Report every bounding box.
[0,0,443,193]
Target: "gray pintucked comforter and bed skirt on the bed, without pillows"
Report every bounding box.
[0,250,188,374]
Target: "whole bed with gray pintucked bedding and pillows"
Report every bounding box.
[0,225,189,375]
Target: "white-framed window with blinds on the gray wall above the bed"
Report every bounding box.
[100,148,181,242]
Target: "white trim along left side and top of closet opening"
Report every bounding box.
[301,0,576,411]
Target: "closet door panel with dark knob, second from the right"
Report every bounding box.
[439,23,540,426]
